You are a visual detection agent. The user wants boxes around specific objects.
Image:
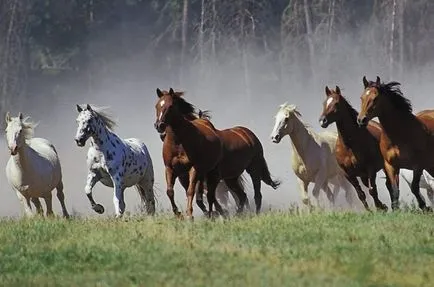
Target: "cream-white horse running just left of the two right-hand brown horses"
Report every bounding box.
[271,103,352,209]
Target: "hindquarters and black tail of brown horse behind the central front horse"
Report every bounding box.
[157,90,280,216]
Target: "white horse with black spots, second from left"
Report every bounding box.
[75,105,155,217]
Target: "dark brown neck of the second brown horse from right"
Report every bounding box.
[336,101,361,147]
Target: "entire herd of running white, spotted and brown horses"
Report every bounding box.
[6,77,434,219]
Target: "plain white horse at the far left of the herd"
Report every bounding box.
[6,112,69,217]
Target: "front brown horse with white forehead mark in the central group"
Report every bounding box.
[155,89,225,218]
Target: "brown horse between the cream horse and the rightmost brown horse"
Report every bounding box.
[319,86,391,211]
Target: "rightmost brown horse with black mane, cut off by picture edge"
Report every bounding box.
[357,77,434,211]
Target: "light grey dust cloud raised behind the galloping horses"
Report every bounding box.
[0,30,434,219]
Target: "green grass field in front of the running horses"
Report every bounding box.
[0,212,434,287]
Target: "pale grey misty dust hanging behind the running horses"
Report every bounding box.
[0,0,434,216]
